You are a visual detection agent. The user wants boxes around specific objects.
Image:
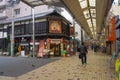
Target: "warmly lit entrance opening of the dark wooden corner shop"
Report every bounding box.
[50,43,61,56]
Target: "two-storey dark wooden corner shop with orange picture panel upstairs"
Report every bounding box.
[1,11,71,57]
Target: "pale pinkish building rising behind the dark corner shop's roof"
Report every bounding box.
[0,0,53,21]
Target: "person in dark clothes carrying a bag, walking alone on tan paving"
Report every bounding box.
[79,42,88,64]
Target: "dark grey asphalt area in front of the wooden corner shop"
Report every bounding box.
[0,57,59,77]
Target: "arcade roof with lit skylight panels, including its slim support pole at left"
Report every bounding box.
[18,0,113,56]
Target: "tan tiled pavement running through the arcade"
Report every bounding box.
[0,51,115,80]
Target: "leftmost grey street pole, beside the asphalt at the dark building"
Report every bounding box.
[11,7,14,56]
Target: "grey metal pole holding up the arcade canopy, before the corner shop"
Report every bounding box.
[32,8,35,57]
